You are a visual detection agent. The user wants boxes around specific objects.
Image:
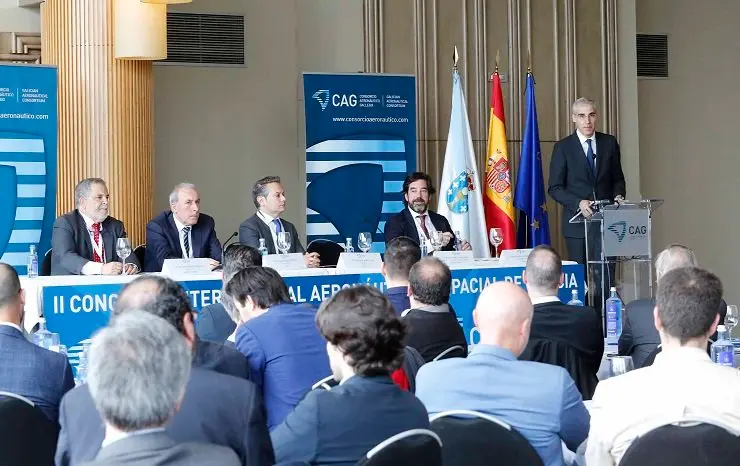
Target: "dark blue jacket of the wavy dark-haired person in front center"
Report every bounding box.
[271,375,429,466]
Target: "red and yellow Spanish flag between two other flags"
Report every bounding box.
[483,68,516,251]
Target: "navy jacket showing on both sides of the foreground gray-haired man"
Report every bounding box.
[55,367,274,466]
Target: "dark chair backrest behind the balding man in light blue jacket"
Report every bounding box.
[429,410,543,466]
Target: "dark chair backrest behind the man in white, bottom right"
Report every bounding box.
[619,422,740,466]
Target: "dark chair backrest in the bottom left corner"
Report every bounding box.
[0,394,59,466]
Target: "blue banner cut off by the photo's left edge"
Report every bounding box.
[0,64,57,275]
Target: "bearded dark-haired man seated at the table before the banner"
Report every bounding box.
[384,172,470,251]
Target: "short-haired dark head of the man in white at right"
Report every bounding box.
[655,267,723,344]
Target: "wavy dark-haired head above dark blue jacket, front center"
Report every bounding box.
[316,286,406,376]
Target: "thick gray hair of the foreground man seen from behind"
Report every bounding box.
[87,310,191,432]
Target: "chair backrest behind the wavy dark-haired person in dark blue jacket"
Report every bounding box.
[357,429,442,466]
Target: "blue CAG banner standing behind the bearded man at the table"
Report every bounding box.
[303,73,416,252]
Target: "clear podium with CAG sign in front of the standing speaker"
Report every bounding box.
[569,199,663,328]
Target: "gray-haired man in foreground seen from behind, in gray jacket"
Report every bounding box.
[83,311,241,466]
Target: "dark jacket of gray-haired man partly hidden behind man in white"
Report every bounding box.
[619,299,727,369]
